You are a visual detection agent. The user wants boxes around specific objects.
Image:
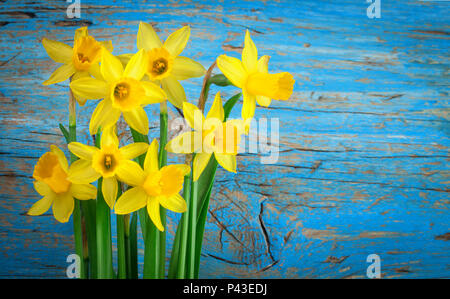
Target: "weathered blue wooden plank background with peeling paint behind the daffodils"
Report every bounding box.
[0,0,450,278]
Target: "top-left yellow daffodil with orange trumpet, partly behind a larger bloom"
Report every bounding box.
[42,27,113,105]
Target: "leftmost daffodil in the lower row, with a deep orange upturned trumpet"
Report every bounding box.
[28,145,97,223]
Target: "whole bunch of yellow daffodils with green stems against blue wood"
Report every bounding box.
[28,22,294,278]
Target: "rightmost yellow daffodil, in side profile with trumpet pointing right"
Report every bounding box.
[217,30,295,122]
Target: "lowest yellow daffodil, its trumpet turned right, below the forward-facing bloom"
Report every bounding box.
[114,139,191,231]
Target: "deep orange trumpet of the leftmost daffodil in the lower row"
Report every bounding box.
[33,152,71,193]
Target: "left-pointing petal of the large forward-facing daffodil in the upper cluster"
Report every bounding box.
[70,77,109,100]
